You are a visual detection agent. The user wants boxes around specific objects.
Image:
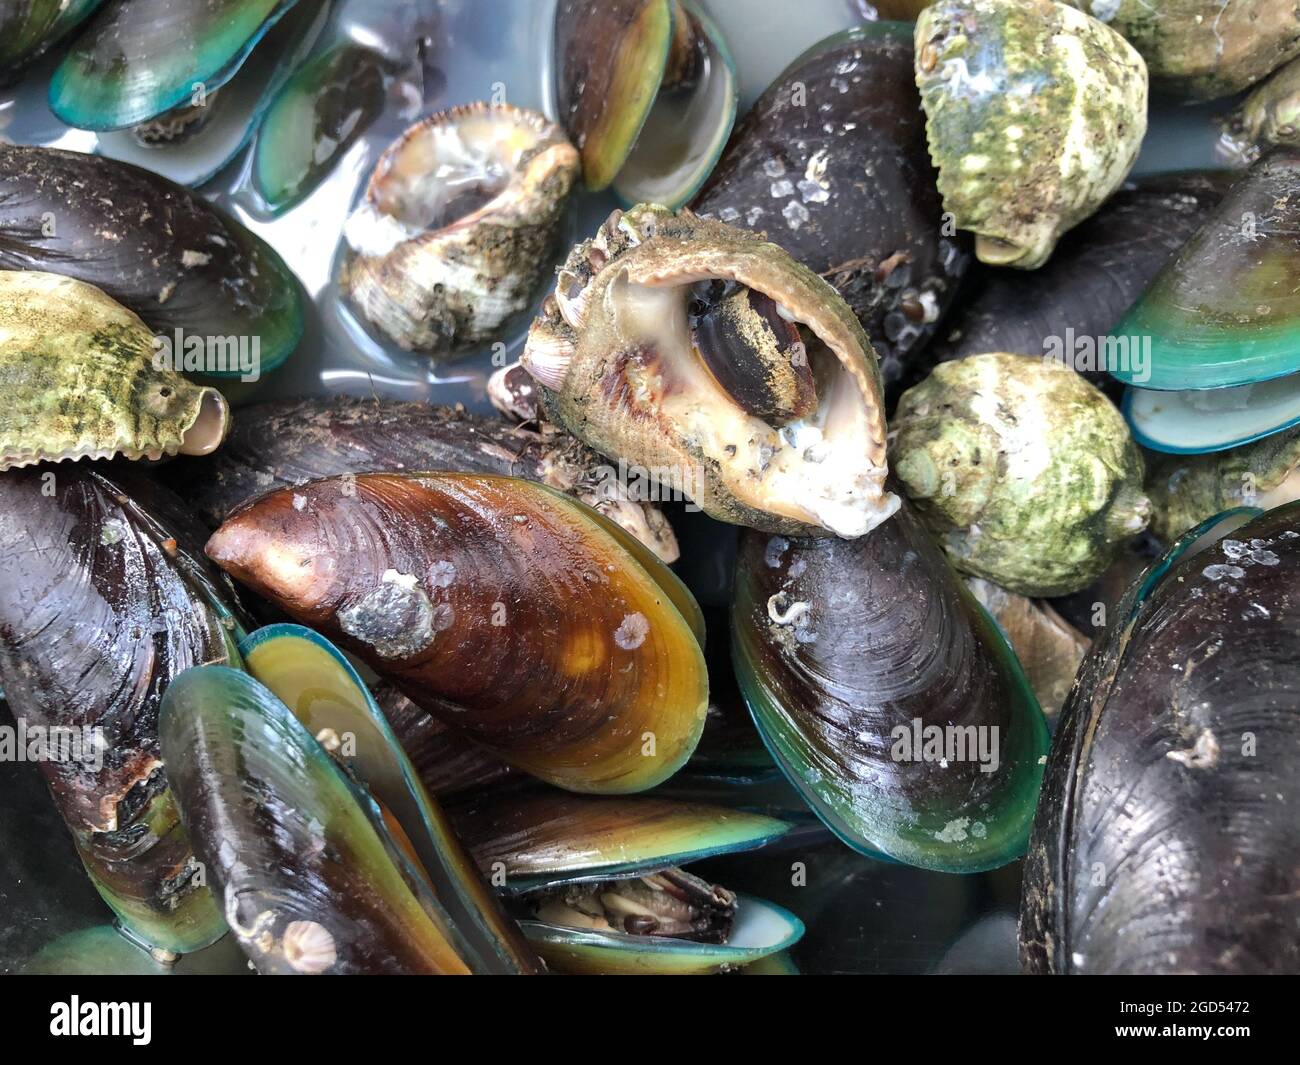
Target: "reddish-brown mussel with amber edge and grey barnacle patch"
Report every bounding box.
[208,473,709,793]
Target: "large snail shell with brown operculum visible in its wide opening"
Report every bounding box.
[521,204,898,536]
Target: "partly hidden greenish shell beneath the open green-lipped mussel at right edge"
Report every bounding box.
[1147,429,1300,544]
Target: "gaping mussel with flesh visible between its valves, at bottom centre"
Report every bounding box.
[455,791,803,974]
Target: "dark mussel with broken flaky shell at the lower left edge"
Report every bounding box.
[0,463,241,953]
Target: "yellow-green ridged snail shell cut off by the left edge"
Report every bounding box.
[0,270,230,469]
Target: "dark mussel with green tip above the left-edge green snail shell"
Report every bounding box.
[0,144,303,381]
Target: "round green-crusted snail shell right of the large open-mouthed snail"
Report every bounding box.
[891,354,1151,596]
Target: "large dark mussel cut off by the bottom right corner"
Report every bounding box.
[1021,503,1300,974]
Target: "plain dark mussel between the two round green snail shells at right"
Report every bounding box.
[930,172,1232,385]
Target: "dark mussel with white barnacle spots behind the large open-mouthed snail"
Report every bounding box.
[692,22,971,397]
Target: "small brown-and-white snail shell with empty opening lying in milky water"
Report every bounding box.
[341,103,580,358]
